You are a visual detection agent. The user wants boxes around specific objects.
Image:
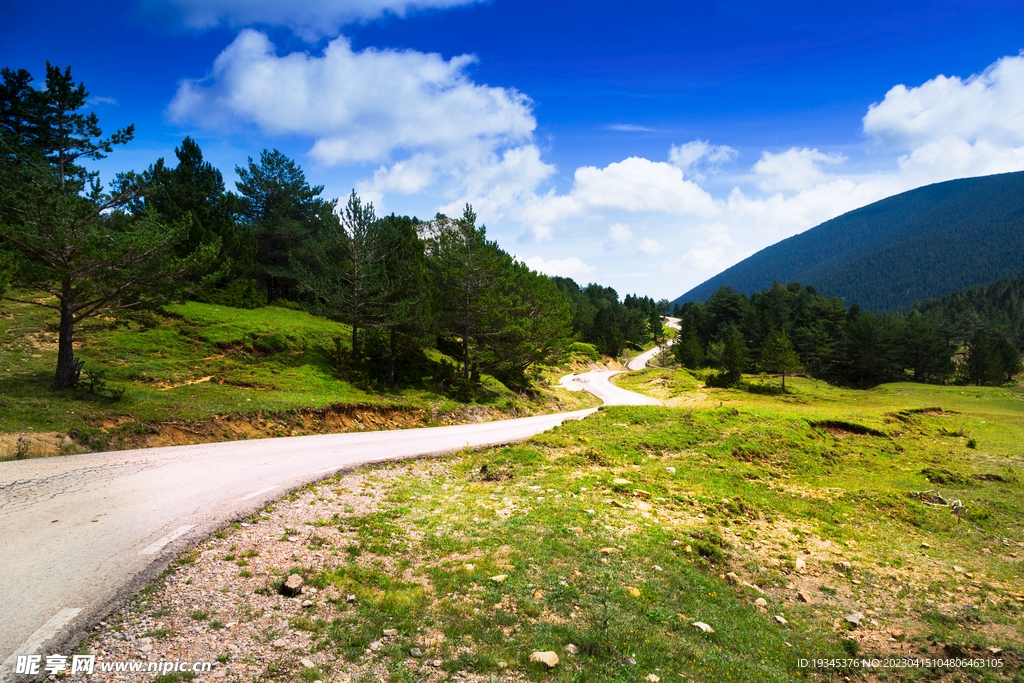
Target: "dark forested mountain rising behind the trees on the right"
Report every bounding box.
[673,171,1024,312]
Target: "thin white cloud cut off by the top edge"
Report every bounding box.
[149,0,478,40]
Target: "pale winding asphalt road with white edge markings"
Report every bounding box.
[0,339,675,682]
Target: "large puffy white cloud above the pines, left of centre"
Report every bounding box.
[168,29,553,202]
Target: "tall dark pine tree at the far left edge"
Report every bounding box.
[0,62,217,389]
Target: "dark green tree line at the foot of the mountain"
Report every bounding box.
[673,283,1024,386]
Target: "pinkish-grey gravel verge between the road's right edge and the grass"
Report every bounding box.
[73,461,517,683]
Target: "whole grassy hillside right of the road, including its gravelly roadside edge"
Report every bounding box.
[85,369,1024,683]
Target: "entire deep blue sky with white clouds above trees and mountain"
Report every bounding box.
[0,0,1024,299]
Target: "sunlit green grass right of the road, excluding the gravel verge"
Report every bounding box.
[260,371,1024,682]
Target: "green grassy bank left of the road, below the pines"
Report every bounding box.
[0,302,587,458]
